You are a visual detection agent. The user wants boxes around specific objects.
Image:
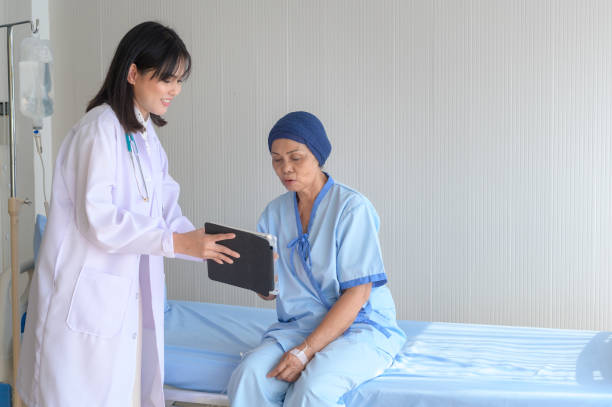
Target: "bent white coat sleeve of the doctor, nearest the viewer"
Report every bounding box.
[71,121,174,257]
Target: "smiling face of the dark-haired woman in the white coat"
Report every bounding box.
[128,64,183,119]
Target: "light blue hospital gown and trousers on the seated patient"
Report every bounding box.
[229,176,405,407]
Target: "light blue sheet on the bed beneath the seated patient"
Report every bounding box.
[165,301,612,407]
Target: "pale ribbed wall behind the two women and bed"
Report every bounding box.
[50,0,612,329]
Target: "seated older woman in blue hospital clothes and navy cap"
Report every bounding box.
[228,112,405,407]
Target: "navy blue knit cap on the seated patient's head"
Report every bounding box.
[268,112,331,166]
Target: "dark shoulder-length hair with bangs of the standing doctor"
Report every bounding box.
[86,21,191,133]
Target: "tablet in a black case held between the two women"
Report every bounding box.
[204,222,276,296]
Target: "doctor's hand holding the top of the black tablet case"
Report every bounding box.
[172,229,240,264]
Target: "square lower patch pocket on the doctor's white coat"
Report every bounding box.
[66,268,131,338]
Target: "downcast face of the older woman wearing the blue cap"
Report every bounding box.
[270,138,321,192]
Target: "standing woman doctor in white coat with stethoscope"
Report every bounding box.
[17,22,238,407]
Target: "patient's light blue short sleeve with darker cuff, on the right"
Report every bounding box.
[336,199,387,291]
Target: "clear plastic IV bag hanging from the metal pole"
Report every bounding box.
[19,37,53,128]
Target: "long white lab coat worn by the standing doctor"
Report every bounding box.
[17,105,194,407]
